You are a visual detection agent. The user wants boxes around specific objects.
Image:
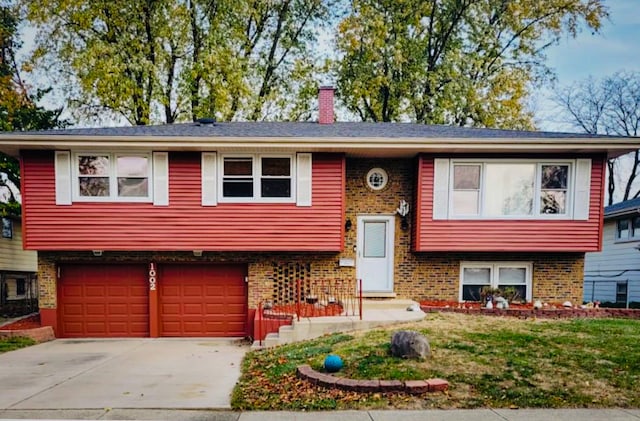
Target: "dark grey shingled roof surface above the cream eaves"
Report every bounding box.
[10,122,614,139]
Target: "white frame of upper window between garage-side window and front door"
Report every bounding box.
[216,153,297,203]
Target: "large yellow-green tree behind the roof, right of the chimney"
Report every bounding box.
[335,0,607,129]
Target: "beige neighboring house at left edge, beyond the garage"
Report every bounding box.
[0,217,38,315]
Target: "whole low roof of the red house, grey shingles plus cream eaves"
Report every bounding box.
[0,122,640,157]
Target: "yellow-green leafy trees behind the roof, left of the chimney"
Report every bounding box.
[22,0,338,124]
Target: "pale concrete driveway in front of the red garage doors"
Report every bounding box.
[0,338,249,409]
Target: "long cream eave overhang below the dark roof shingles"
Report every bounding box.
[0,133,640,158]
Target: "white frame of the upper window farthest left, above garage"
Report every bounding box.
[71,150,153,203]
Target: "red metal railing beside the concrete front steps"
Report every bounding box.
[254,279,362,345]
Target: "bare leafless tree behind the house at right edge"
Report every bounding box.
[554,72,640,205]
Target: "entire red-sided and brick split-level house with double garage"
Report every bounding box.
[0,89,640,337]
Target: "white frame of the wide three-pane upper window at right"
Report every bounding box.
[447,158,577,220]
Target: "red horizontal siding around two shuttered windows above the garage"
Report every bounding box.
[22,151,345,251]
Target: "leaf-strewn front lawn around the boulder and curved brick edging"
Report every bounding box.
[232,313,640,410]
